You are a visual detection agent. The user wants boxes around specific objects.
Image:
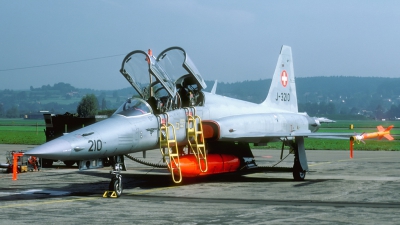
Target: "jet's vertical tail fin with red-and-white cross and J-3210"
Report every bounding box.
[261,45,298,112]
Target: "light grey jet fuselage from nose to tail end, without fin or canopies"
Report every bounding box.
[29,93,319,160]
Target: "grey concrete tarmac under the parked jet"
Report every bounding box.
[0,145,400,224]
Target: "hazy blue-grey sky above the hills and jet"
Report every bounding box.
[0,0,400,90]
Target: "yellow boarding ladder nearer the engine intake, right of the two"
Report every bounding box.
[185,107,208,173]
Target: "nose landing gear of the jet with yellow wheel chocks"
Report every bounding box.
[103,155,126,198]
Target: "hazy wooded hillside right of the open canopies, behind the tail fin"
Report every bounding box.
[206,76,400,119]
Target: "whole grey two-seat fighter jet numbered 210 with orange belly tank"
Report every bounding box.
[26,46,390,197]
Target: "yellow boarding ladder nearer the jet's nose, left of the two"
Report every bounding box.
[157,113,182,183]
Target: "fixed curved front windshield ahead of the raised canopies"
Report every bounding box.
[114,98,152,116]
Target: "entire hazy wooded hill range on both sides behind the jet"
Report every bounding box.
[0,76,400,119]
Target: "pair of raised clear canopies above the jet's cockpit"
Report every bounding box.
[120,47,207,100]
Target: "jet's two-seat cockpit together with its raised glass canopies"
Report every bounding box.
[119,47,207,114]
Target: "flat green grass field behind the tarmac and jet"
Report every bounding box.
[0,119,400,151]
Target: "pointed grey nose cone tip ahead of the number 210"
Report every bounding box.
[25,139,72,160]
